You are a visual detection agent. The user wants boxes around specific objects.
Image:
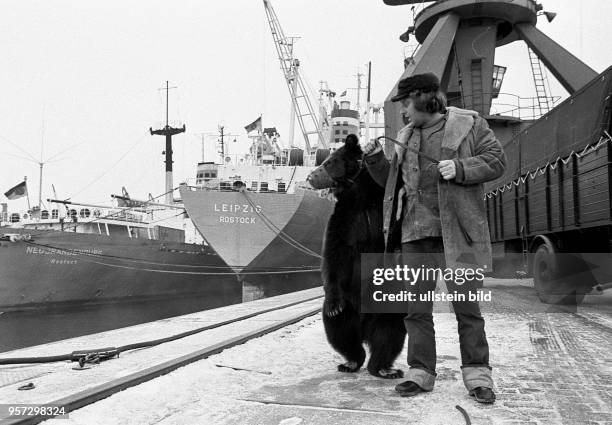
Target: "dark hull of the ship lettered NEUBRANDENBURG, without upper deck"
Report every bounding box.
[0,229,242,311]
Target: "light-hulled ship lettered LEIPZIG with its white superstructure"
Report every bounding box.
[179,119,333,298]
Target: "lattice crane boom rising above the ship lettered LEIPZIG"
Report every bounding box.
[263,0,327,154]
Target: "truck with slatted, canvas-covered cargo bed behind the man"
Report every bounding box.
[485,67,612,304]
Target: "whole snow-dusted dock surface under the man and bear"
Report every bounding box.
[0,279,612,425]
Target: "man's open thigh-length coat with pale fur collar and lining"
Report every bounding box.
[365,107,506,270]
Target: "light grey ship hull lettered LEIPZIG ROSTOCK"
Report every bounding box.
[181,188,333,298]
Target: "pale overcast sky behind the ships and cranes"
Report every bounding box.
[0,0,612,210]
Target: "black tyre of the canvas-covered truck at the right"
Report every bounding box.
[533,242,584,305]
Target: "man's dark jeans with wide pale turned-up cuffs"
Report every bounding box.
[402,238,493,391]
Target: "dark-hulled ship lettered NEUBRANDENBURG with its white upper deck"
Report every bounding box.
[0,195,242,312]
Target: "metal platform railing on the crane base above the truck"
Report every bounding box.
[448,93,561,120]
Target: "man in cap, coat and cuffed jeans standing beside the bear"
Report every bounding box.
[364,74,506,403]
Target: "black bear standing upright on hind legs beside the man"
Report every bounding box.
[308,134,406,379]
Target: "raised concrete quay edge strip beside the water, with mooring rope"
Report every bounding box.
[0,288,322,423]
